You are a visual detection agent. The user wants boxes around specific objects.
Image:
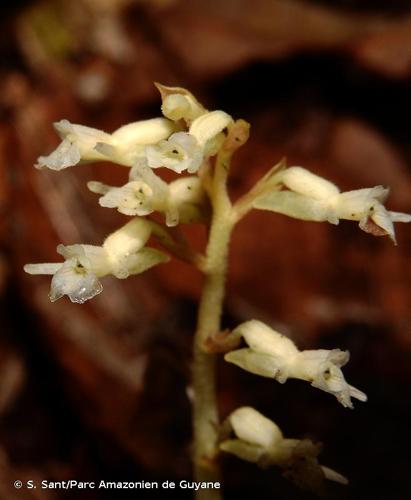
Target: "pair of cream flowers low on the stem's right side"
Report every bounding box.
[220,320,367,492]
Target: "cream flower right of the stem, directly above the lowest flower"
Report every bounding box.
[224,320,367,408]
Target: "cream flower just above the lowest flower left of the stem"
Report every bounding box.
[87,163,207,226]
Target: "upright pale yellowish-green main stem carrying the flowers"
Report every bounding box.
[193,122,248,500]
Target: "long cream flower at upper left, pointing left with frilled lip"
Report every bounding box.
[35,118,176,170]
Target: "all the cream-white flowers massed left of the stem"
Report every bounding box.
[24,85,233,303]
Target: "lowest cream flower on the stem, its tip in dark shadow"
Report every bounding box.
[220,407,348,491]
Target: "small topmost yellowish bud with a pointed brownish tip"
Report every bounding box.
[155,83,207,125]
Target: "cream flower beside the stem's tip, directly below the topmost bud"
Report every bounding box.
[146,111,233,173]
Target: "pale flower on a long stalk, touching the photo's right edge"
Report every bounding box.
[253,167,411,243]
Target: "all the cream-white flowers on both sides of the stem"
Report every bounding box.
[25,85,411,492]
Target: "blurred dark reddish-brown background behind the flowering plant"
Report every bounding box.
[0,0,411,500]
